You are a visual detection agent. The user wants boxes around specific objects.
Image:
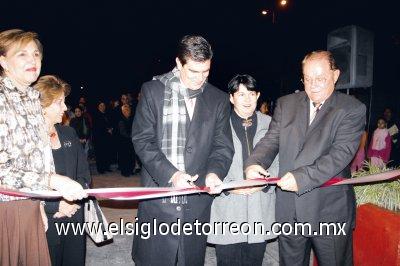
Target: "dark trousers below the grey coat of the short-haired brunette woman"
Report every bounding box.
[215,242,267,266]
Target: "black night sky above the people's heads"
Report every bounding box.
[0,0,400,120]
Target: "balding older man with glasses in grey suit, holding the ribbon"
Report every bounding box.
[246,51,366,266]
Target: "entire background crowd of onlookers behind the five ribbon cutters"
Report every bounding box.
[62,93,400,177]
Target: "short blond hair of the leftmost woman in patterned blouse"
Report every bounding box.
[0,29,43,75]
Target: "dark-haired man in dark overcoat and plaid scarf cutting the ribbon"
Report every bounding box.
[132,36,233,265]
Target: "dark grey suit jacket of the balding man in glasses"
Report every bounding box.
[246,91,366,233]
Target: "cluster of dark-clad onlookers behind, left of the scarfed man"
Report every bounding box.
[62,93,140,177]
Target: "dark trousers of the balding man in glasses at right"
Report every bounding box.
[279,231,353,266]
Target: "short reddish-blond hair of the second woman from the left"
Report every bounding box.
[33,75,71,108]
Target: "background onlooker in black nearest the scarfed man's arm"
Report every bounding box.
[118,104,135,177]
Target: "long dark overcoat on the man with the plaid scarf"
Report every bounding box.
[132,80,234,265]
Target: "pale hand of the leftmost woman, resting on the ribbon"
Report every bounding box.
[50,174,88,201]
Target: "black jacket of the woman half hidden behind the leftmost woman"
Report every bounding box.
[45,125,91,243]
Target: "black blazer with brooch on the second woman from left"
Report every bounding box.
[45,124,92,218]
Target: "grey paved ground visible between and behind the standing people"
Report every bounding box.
[86,168,279,266]
